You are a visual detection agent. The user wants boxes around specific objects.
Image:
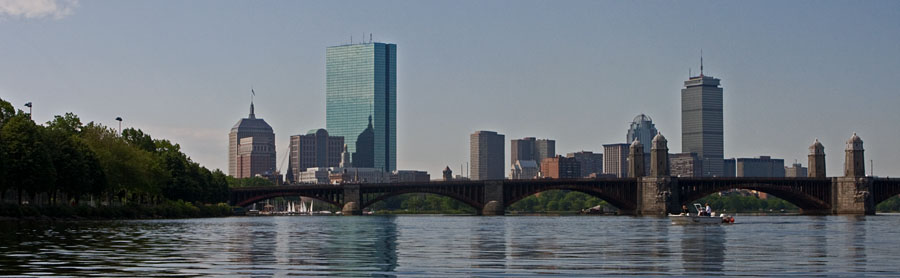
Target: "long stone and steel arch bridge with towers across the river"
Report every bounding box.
[231,134,900,215]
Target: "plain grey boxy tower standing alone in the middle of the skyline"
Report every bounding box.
[469,130,504,180]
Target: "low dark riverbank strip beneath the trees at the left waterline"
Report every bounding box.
[0,201,233,220]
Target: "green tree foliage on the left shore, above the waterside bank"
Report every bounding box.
[0,95,236,211]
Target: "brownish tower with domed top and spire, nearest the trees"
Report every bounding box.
[228,101,275,178]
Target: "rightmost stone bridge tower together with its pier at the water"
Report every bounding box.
[832,133,875,214]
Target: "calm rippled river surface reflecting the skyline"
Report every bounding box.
[0,215,900,277]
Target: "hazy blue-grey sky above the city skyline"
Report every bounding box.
[0,0,900,178]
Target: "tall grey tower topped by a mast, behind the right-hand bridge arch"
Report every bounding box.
[681,58,725,177]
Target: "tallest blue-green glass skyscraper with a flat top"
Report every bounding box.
[325,42,397,172]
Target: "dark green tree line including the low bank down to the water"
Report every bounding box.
[0,99,271,218]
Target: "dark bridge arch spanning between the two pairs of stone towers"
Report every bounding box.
[681,182,831,212]
